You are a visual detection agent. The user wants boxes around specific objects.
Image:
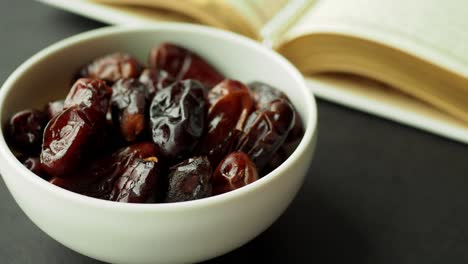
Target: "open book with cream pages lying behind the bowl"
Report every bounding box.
[40,0,468,143]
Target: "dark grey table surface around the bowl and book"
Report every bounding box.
[0,0,468,263]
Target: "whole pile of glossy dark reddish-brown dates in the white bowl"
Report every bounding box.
[5,43,303,203]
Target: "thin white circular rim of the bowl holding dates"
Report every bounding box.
[0,22,317,212]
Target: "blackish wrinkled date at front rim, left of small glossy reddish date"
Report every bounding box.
[165,156,212,203]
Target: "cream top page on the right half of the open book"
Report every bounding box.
[279,0,468,76]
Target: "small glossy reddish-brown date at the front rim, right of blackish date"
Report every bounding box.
[212,152,258,195]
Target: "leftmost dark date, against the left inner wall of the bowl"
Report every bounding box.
[6,110,49,155]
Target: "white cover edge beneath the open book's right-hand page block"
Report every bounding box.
[306,74,468,144]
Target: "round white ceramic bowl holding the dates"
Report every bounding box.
[0,24,317,263]
